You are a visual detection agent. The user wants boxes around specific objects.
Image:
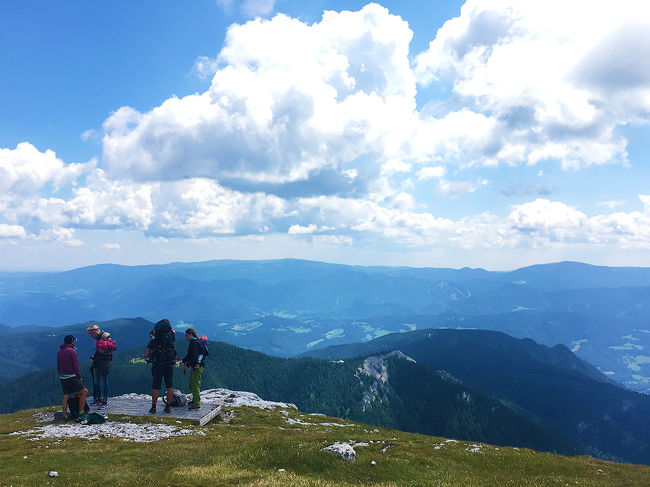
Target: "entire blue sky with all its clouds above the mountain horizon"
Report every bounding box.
[0,0,650,270]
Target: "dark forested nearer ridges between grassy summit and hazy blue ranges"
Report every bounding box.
[0,326,650,464]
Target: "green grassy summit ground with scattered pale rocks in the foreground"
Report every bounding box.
[0,407,650,487]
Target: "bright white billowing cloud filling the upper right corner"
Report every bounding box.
[416,0,650,168]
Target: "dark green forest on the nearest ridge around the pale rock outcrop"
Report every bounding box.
[0,343,581,453]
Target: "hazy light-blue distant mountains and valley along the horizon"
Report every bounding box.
[0,260,650,392]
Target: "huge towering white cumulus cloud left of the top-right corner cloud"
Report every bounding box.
[103,5,415,195]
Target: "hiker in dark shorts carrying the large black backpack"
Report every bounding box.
[144,319,177,414]
